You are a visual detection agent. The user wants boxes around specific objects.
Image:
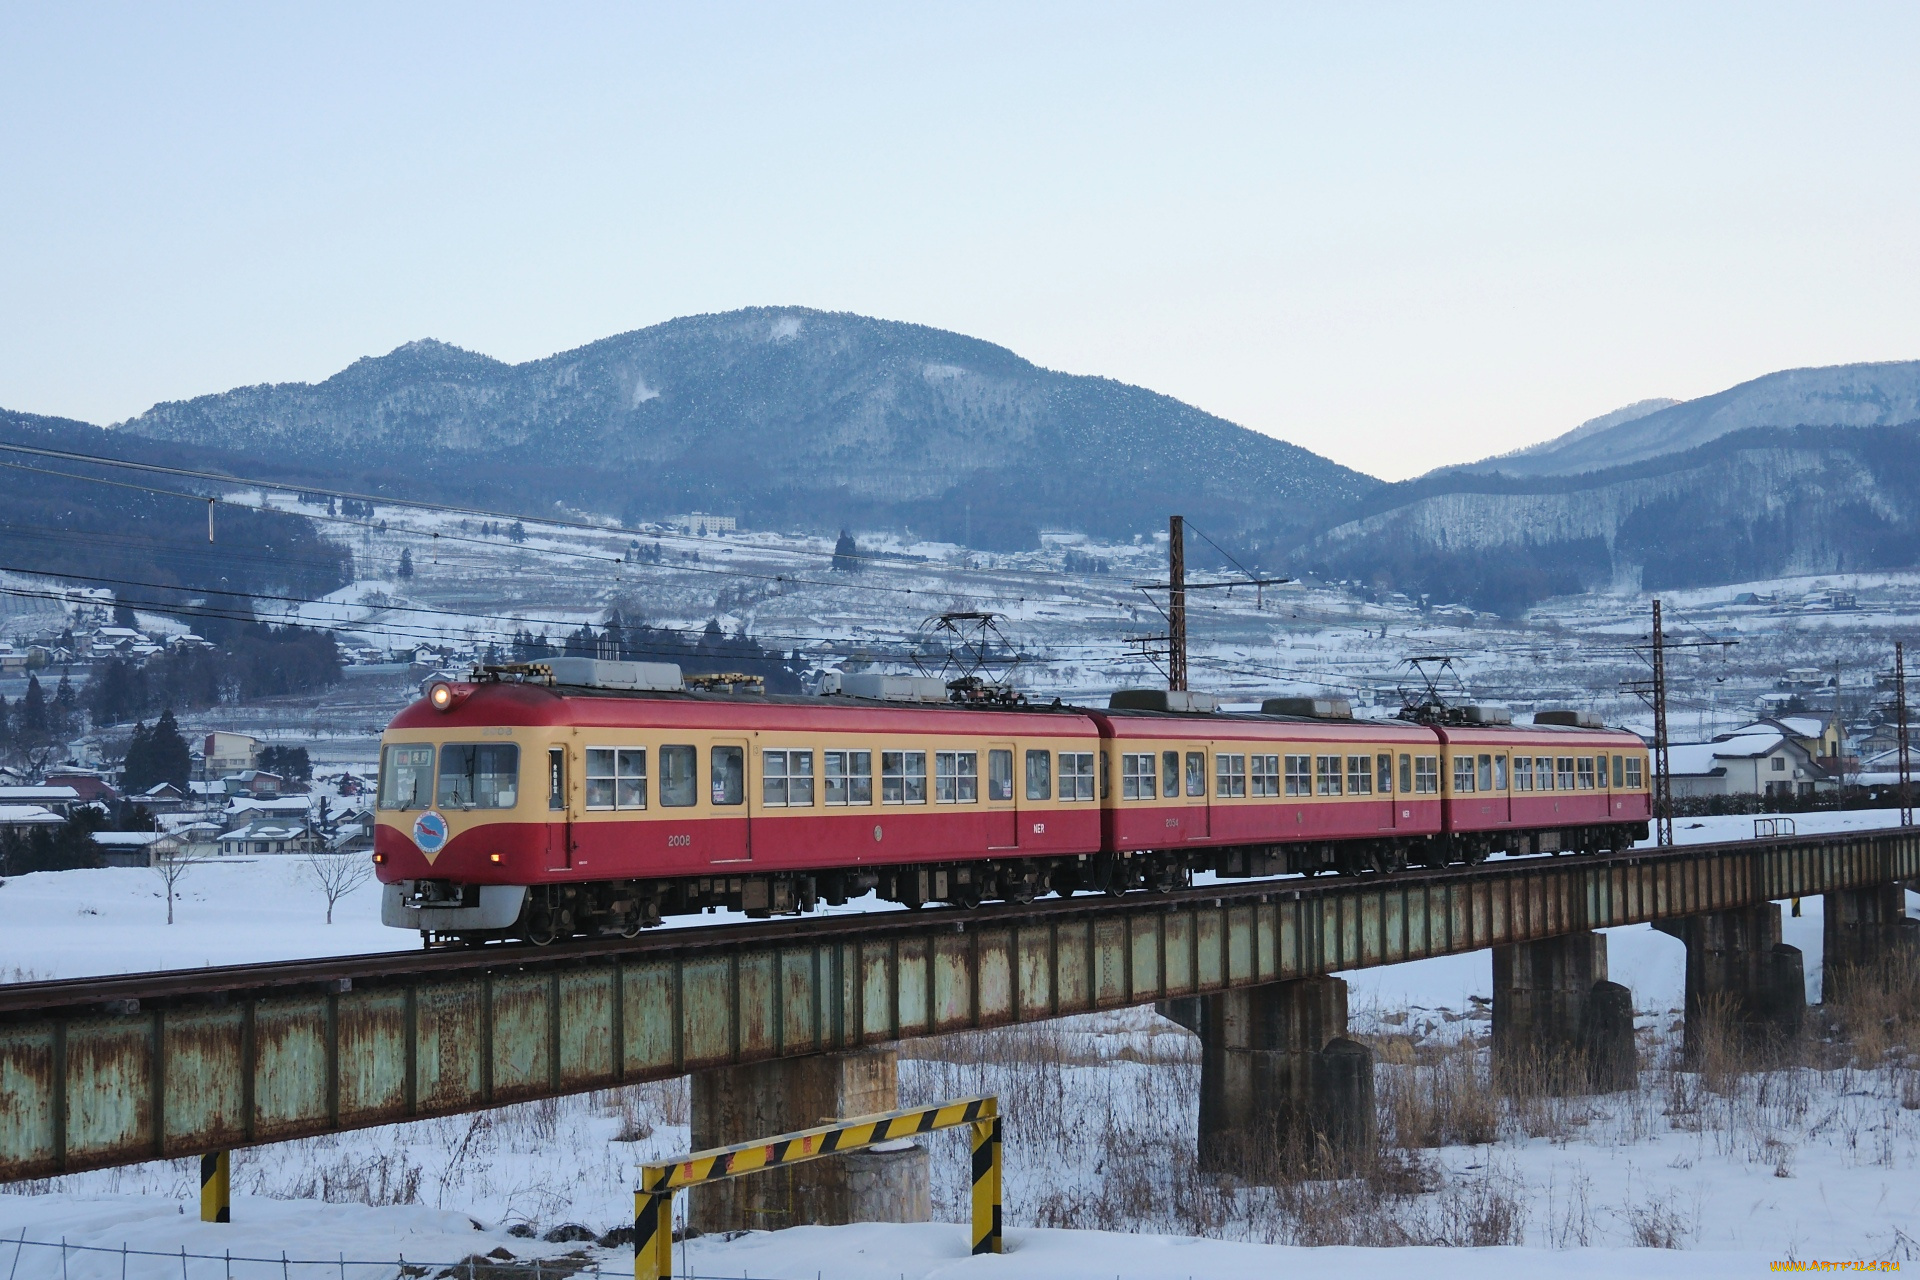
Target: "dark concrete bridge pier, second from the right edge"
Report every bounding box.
[1653,902,1807,1063]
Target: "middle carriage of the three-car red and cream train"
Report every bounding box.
[1094,689,1446,885]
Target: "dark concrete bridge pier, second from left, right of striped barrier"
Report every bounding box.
[1158,977,1379,1178]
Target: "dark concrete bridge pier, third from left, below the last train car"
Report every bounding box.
[1494,931,1640,1094]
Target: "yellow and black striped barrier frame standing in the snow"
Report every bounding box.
[634,1094,1000,1280]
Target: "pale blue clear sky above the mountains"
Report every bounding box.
[0,2,1920,478]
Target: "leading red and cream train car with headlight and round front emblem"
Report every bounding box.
[374,658,1100,942]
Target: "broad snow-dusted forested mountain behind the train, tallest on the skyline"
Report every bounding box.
[119,307,1379,549]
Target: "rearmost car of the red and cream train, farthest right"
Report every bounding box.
[1434,708,1651,862]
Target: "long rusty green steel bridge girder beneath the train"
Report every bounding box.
[0,831,1920,1180]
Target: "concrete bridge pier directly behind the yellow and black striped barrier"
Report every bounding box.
[687,1048,933,1232]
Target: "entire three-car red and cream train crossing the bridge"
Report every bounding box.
[374,658,1649,942]
